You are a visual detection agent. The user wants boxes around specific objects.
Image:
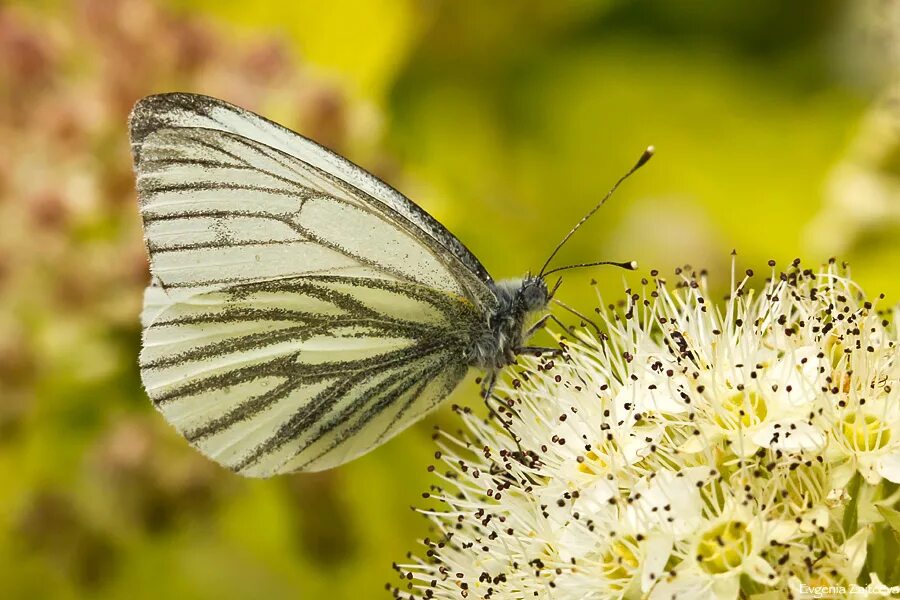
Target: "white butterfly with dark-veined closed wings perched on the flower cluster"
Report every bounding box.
[129,93,652,477]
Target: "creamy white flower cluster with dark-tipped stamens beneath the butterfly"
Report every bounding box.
[392,261,900,600]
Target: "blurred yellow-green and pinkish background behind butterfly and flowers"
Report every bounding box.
[0,0,900,598]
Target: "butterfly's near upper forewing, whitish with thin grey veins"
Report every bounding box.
[134,128,492,305]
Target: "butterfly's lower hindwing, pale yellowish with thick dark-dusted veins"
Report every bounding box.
[141,277,480,477]
